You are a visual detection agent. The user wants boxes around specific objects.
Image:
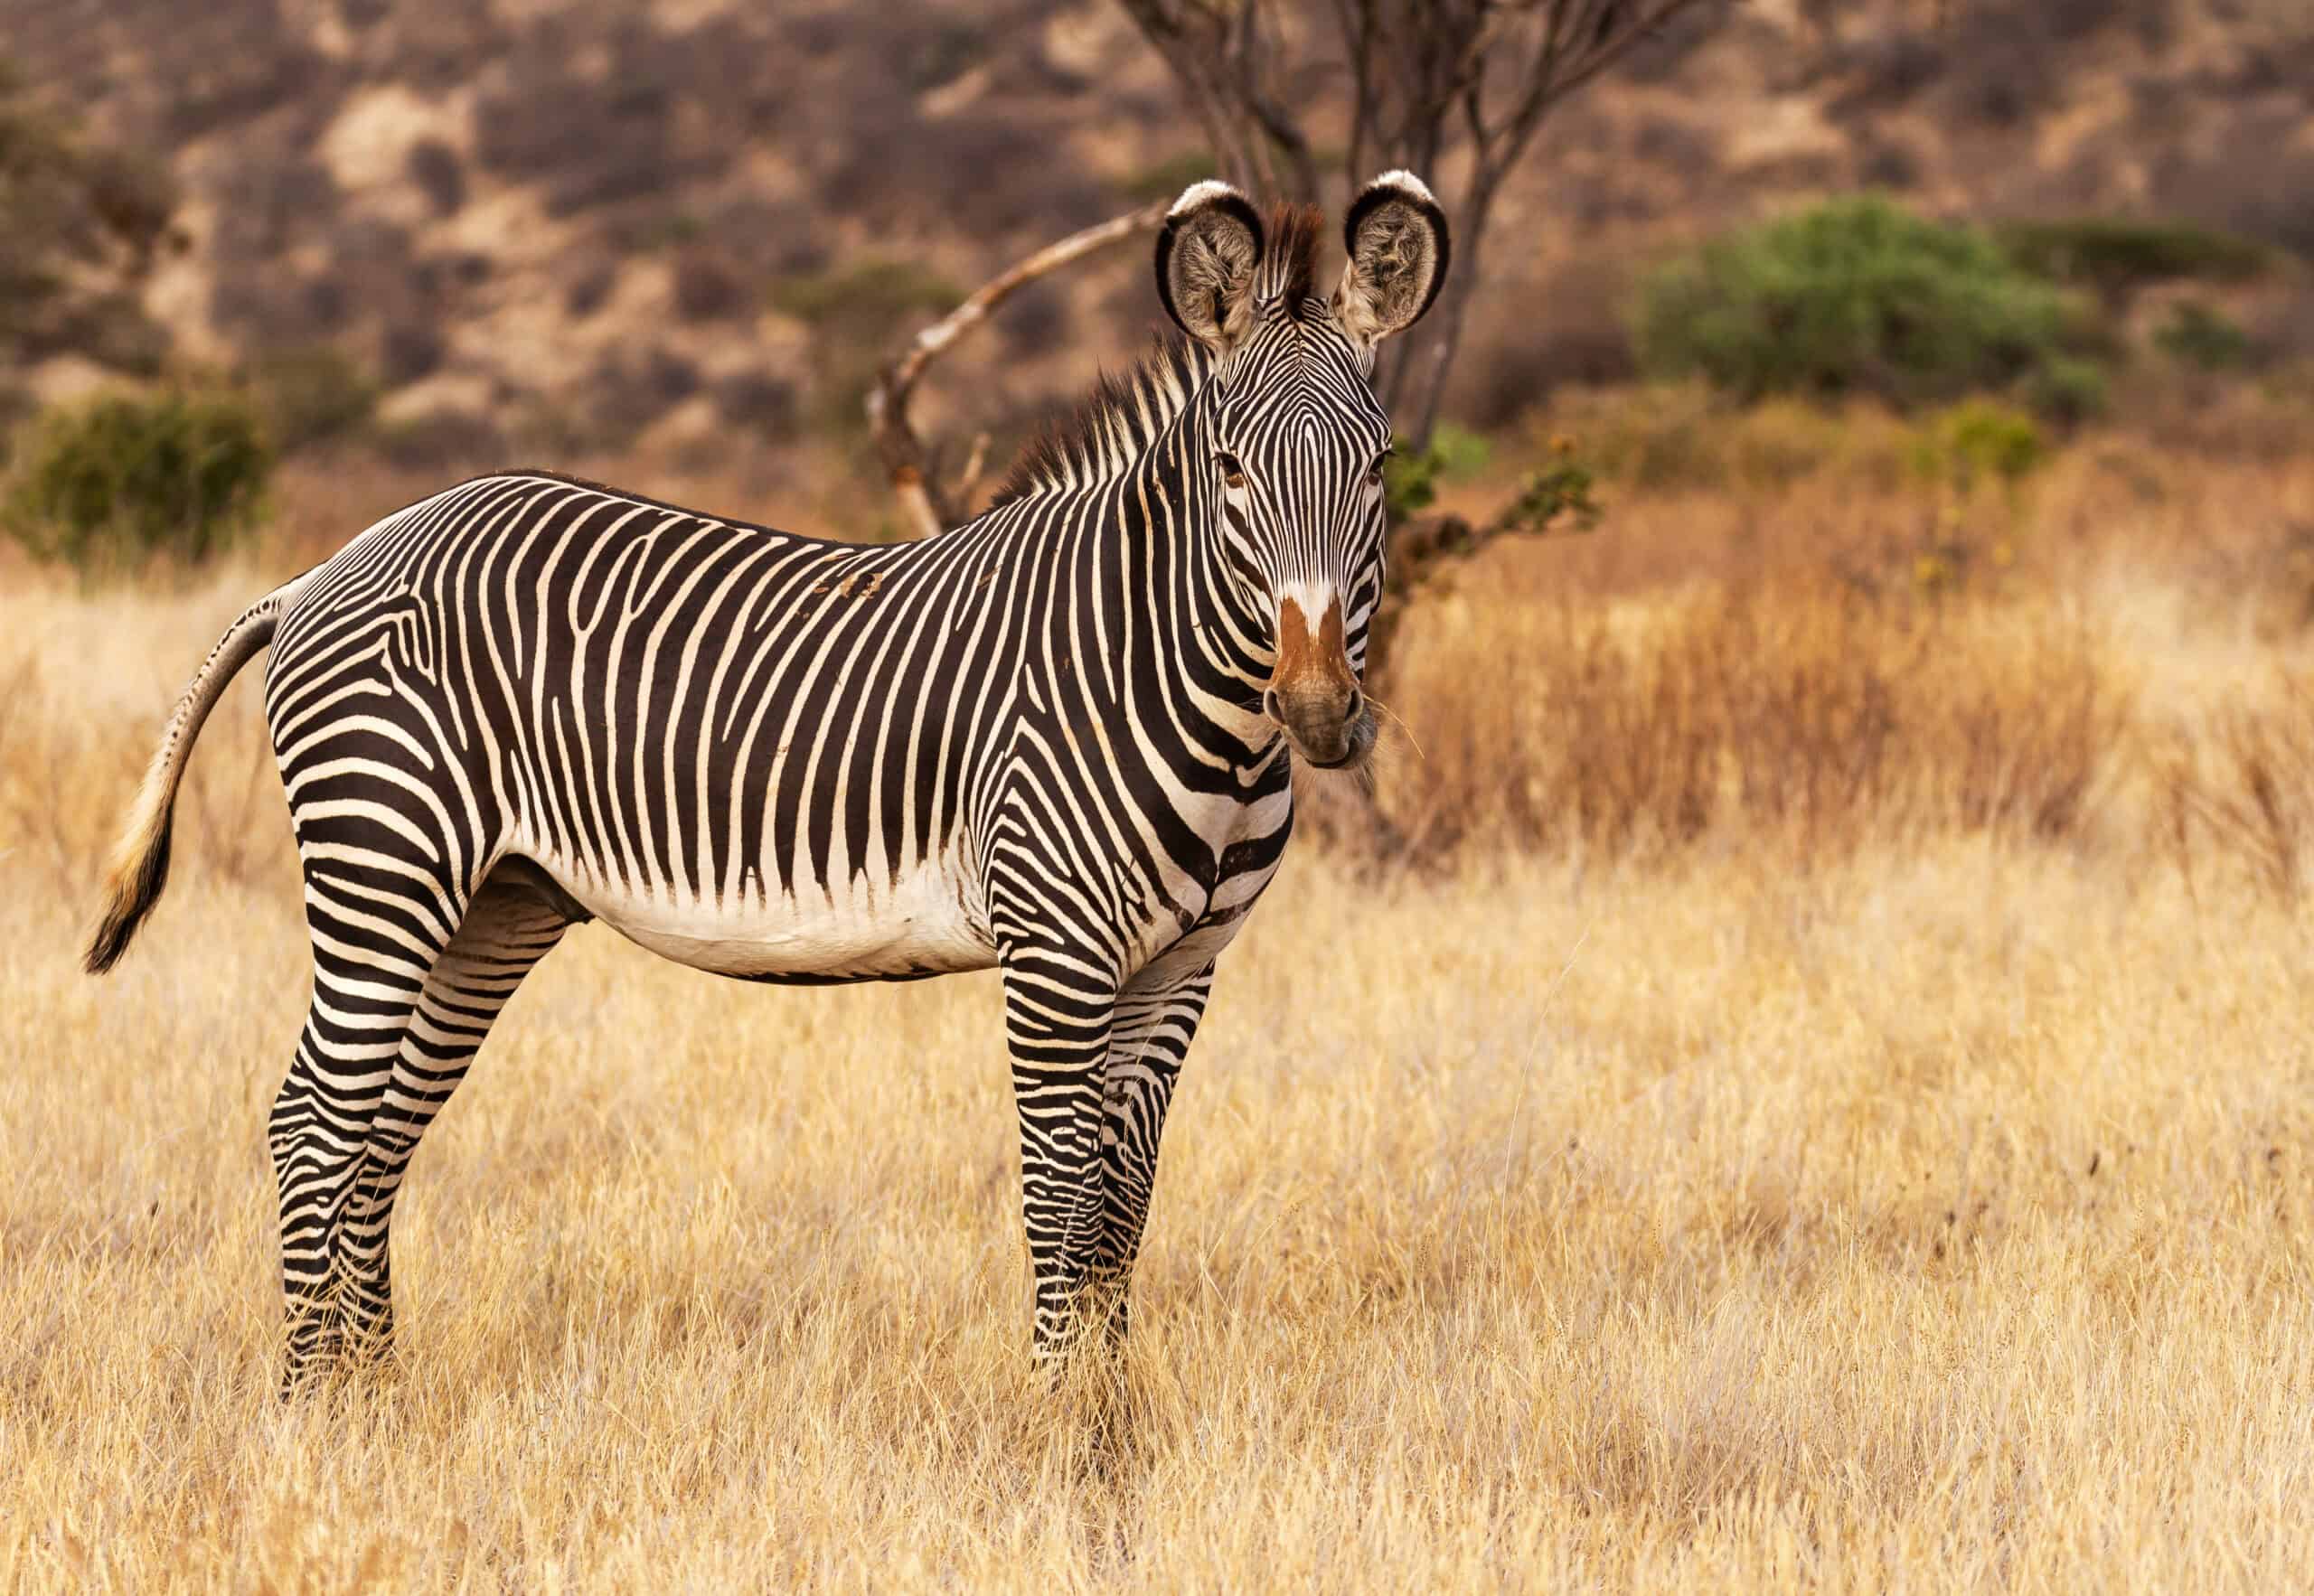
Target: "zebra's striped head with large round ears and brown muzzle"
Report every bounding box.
[1157,171,1449,768]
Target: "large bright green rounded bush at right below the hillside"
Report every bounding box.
[1633,197,2096,418]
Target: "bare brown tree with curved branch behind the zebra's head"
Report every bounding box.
[868,0,1738,754]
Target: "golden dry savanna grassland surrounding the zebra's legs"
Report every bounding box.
[0,414,2314,1591]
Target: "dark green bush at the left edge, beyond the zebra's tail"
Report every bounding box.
[7,391,273,574]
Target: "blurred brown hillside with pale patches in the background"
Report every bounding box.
[5,0,2314,490]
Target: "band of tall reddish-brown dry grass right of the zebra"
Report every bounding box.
[1328,439,2314,886]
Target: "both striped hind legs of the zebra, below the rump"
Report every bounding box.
[271,860,571,1390]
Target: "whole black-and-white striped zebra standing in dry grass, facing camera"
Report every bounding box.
[88,171,1449,1378]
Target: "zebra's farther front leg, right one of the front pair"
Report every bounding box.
[1087,964,1212,1347]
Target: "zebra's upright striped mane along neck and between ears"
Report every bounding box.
[988,206,1326,509]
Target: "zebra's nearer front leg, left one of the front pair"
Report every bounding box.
[1004,951,1117,1365]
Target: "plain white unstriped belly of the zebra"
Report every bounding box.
[557,860,997,983]
